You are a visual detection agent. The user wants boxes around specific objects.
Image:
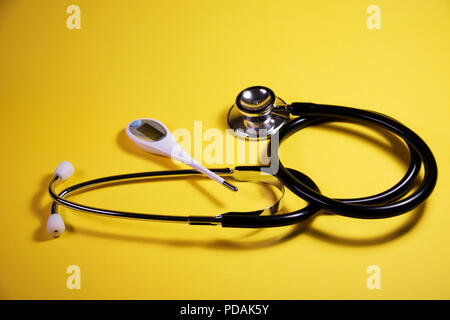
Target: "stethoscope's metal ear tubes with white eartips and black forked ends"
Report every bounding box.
[47,166,320,237]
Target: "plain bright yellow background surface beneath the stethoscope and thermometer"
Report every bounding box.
[0,0,450,299]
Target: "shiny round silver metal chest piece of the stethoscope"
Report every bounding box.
[228,86,289,139]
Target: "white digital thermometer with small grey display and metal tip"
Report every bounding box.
[126,119,237,191]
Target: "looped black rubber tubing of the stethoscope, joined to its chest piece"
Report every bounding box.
[269,103,437,219]
